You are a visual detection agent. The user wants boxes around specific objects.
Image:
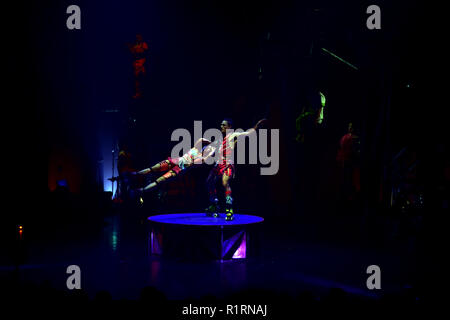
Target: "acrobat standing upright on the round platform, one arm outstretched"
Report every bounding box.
[206,118,266,221]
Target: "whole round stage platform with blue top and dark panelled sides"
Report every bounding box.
[148,212,264,261]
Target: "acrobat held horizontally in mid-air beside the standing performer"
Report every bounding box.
[136,138,215,192]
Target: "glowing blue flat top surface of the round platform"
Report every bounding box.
[148,213,264,226]
